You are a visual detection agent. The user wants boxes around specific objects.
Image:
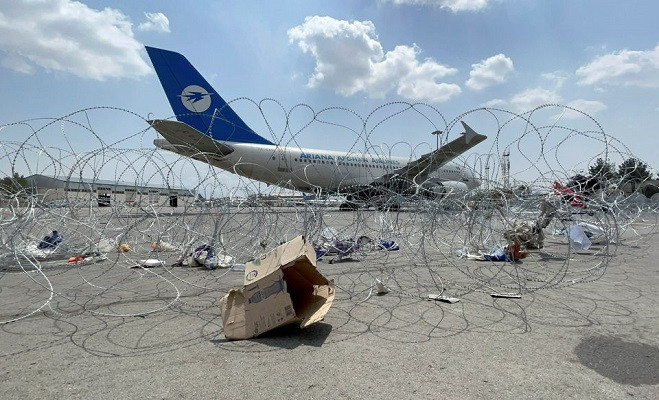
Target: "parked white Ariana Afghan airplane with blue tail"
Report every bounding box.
[146,46,487,210]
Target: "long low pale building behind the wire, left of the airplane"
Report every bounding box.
[26,174,196,207]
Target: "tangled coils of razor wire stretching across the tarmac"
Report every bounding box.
[0,103,659,332]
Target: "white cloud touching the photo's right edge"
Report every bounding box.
[576,45,659,88]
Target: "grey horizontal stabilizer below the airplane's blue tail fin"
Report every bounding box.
[148,119,233,156]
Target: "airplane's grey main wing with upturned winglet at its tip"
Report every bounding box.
[373,121,487,183]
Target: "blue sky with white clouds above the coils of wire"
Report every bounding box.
[0,0,659,188]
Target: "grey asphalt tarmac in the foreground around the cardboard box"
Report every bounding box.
[0,213,659,399]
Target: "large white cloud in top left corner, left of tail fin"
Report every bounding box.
[0,0,151,80]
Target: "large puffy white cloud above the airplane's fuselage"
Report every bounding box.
[288,16,462,102]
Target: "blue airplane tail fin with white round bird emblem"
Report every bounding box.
[145,46,273,144]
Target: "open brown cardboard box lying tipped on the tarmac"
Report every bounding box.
[220,236,335,339]
